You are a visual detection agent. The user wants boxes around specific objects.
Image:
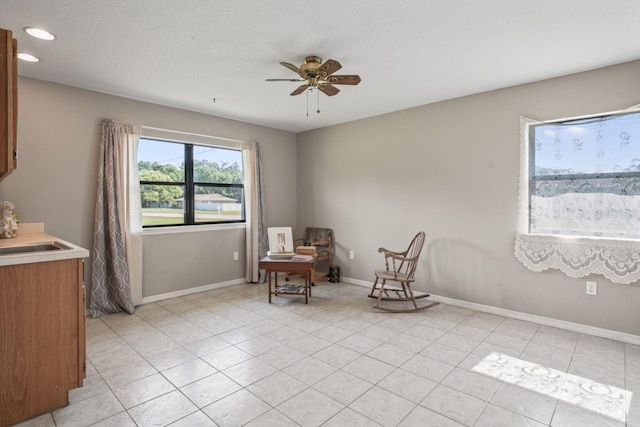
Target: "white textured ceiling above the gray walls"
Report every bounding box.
[0,0,640,132]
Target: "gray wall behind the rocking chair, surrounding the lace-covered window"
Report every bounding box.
[297,61,640,335]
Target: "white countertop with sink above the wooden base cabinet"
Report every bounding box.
[0,227,89,266]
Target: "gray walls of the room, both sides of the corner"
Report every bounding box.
[5,61,640,334]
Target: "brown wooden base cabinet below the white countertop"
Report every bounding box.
[0,258,86,426]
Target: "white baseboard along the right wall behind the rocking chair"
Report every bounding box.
[340,277,640,345]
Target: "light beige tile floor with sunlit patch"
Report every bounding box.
[13,282,640,427]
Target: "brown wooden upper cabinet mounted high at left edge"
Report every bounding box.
[0,28,18,181]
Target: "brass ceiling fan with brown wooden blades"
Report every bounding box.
[267,55,360,96]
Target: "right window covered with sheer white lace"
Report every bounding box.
[528,111,640,239]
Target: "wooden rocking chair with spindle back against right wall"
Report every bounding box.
[369,231,438,313]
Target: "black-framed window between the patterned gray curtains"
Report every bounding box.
[138,137,244,227]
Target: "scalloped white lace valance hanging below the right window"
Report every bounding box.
[515,234,640,284]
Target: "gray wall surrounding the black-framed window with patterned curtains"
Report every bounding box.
[0,78,296,297]
